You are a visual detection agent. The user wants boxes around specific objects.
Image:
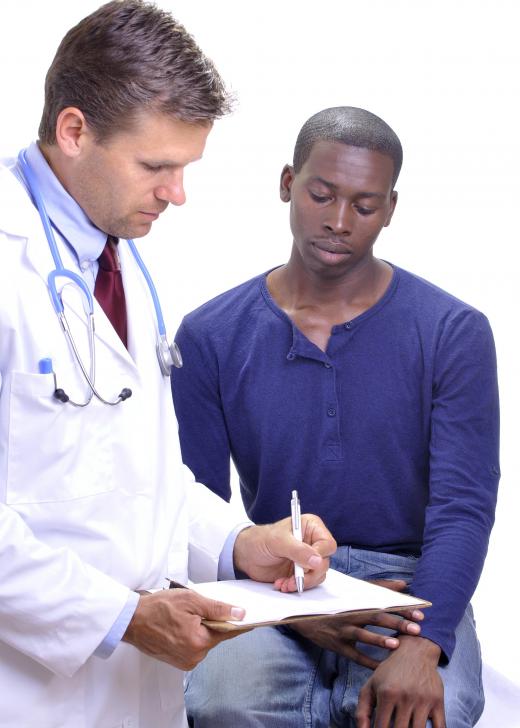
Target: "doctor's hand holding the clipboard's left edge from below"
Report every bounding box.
[123,589,244,670]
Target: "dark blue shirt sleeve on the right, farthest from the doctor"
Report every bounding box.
[410,309,500,660]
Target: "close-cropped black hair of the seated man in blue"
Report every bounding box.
[293,106,403,185]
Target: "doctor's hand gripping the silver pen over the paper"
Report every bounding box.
[233,514,336,592]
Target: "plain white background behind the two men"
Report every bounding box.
[0,0,520,685]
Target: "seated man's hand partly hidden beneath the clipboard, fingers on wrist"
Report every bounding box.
[291,579,424,670]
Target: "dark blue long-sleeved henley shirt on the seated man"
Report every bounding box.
[172,266,499,659]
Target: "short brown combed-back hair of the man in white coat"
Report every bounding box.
[38,0,232,145]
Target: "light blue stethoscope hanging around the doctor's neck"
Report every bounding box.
[18,149,182,407]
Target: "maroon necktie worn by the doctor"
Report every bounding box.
[94,235,127,346]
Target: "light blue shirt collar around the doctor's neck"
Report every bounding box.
[22,142,107,265]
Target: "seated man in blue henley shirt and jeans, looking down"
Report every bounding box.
[172,107,499,728]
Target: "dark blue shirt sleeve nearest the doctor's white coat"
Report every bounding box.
[172,320,231,501]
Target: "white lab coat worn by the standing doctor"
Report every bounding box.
[0,161,241,728]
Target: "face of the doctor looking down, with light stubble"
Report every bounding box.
[66,113,211,238]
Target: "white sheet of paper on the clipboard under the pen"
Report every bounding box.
[190,569,424,626]
